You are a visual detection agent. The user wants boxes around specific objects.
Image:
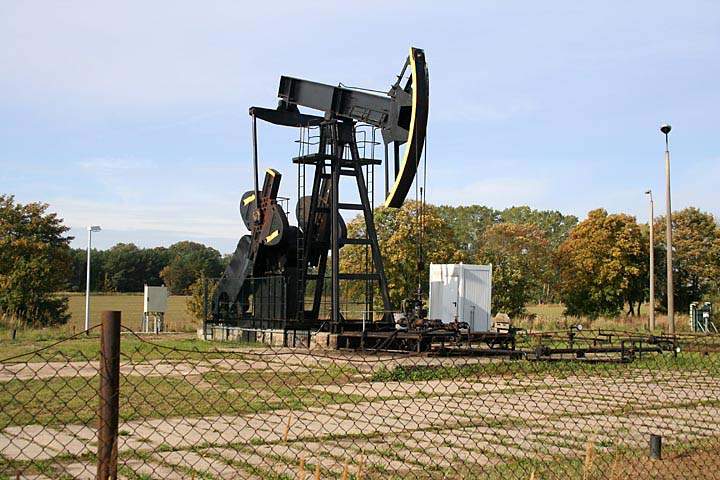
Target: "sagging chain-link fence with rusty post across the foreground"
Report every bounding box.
[0,312,720,480]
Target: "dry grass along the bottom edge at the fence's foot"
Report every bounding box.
[5,436,720,480]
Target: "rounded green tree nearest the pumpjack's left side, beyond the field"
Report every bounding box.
[160,241,224,295]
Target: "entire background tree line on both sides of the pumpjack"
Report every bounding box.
[0,194,720,325]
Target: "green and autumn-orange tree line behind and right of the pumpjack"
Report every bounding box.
[341,202,720,318]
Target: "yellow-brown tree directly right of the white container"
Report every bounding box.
[477,223,551,316]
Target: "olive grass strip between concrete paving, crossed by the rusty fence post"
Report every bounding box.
[0,369,362,430]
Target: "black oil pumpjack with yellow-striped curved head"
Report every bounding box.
[211,48,429,333]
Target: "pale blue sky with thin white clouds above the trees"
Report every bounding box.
[0,0,720,253]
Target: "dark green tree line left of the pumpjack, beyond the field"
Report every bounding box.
[0,194,227,326]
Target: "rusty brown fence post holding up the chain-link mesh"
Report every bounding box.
[96,311,121,480]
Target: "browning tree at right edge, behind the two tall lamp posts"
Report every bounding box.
[655,207,720,312]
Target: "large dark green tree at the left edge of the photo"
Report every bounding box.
[0,195,72,326]
